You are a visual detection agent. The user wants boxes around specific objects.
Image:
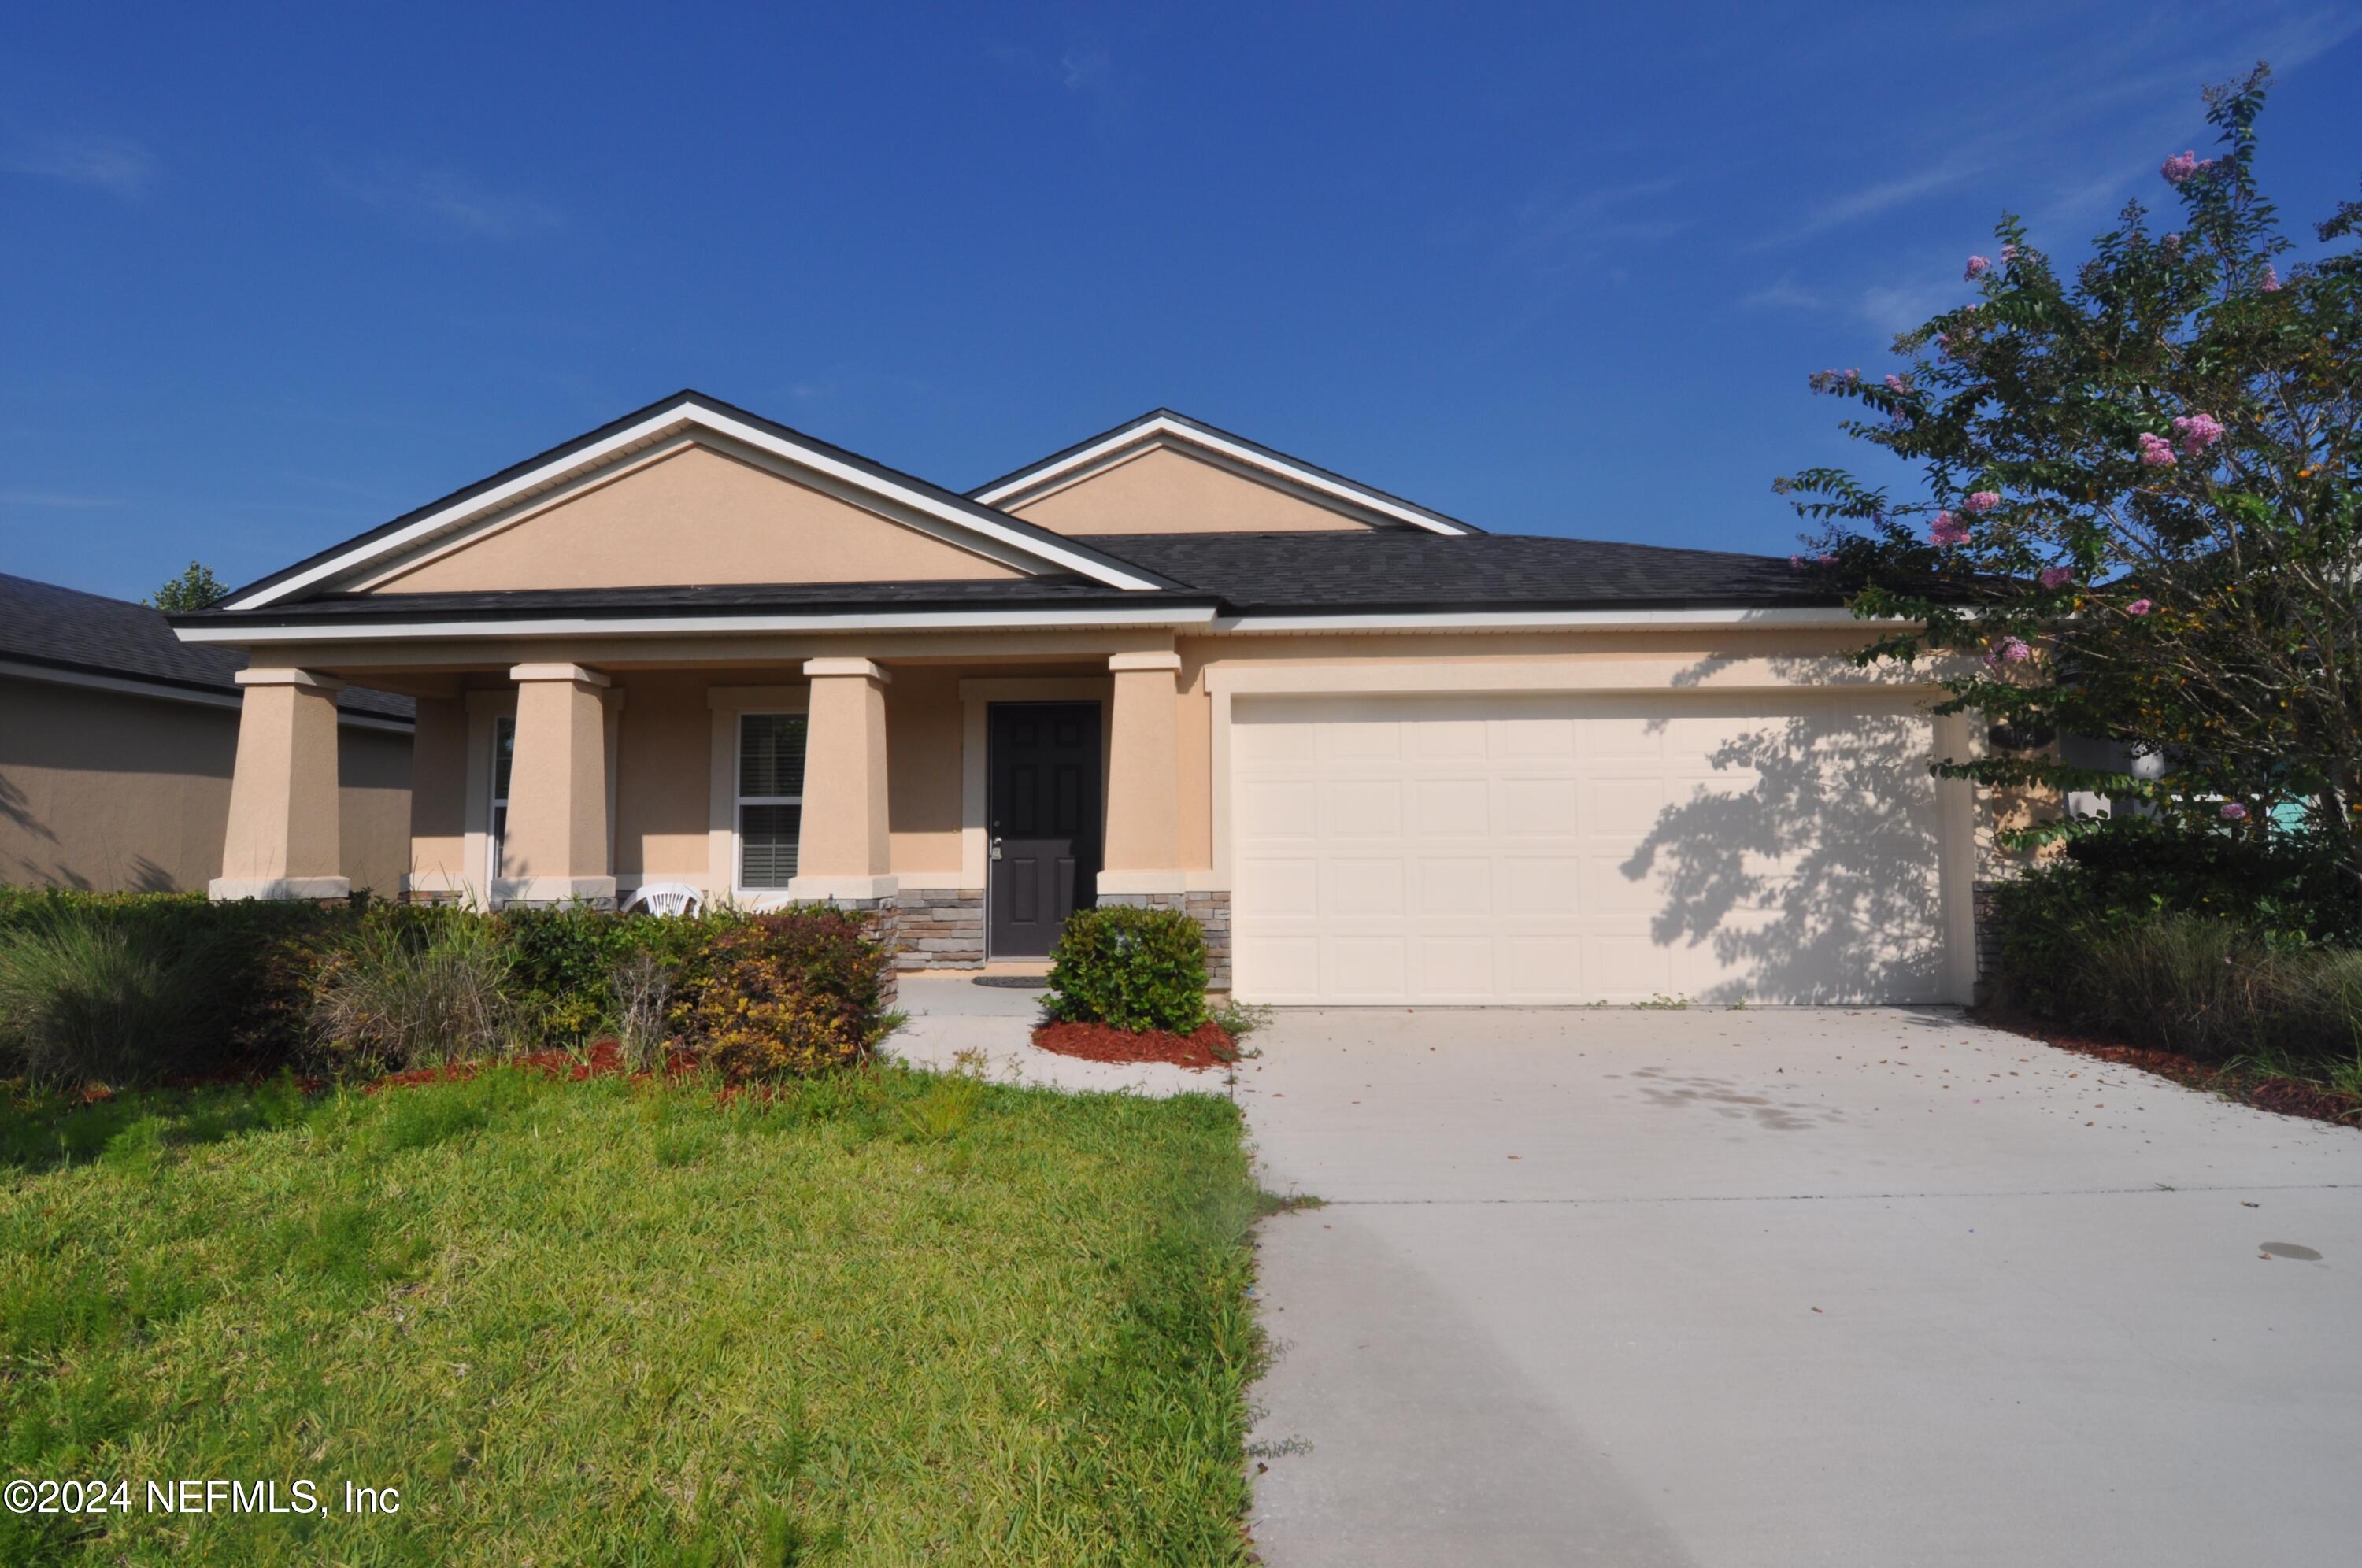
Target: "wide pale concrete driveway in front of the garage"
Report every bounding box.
[1238,1011,2362,1568]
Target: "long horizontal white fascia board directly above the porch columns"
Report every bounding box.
[172,607,1214,645]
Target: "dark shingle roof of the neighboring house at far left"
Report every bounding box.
[0,571,413,720]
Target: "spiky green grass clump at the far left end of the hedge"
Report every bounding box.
[0,912,224,1084]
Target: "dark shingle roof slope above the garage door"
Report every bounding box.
[1063,531,1840,612]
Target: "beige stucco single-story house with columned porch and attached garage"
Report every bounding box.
[175,392,1989,1004]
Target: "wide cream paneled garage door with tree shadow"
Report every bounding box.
[1231,692,1946,1004]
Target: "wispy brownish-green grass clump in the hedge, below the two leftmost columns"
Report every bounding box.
[312,919,517,1074]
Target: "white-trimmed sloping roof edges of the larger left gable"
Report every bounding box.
[222,390,1174,609]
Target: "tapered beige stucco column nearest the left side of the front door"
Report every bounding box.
[787,659,902,900]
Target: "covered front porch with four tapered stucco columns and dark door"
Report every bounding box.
[213,638,1231,985]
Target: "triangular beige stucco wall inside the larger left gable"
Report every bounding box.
[373,446,1020,593]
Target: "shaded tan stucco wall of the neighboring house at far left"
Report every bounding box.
[0,678,411,895]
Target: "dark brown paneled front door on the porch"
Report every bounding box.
[985,701,1098,959]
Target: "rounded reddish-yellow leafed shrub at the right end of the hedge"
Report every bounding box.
[673,907,890,1079]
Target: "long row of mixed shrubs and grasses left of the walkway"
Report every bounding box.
[0,888,890,1084]
